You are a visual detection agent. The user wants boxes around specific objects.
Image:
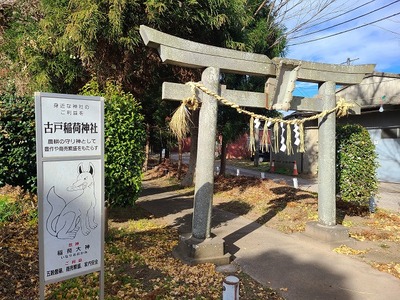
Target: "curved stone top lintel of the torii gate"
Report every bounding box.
[140,25,375,85]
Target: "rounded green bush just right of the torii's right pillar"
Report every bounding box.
[336,124,378,205]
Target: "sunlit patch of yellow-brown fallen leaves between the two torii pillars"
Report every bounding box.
[214,176,318,233]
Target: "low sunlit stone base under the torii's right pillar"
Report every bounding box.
[305,222,350,244]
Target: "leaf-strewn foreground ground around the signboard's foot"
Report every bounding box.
[0,197,283,300]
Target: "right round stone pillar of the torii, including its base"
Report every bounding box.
[306,81,349,243]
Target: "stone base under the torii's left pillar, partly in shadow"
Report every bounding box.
[172,233,230,266]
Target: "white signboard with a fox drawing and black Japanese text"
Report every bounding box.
[35,93,104,299]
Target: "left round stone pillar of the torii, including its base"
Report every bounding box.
[174,67,230,265]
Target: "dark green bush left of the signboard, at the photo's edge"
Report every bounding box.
[0,95,36,192]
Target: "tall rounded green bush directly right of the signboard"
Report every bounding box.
[83,80,146,206]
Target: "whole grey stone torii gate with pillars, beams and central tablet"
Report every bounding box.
[140,25,375,264]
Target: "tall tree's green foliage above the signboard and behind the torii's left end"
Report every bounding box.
[0,0,285,184]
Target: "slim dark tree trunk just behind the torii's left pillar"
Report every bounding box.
[181,110,199,187]
